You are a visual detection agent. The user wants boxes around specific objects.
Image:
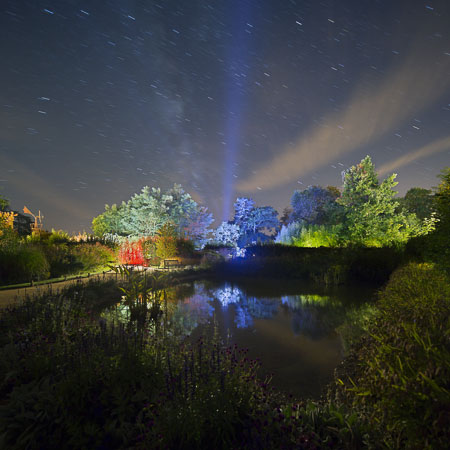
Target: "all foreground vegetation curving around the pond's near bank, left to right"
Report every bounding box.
[0,262,450,449]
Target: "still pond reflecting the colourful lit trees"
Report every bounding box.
[104,279,374,398]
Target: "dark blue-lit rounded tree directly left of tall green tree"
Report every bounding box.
[290,186,340,225]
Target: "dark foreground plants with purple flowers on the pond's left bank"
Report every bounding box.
[0,269,319,449]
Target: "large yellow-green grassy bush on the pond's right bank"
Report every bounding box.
[336,264,450,449]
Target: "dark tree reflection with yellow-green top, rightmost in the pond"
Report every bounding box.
[281,295,345,340]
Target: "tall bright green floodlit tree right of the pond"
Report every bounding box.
[337,156,434,246]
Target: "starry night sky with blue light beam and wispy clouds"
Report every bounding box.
[0,0,450,232]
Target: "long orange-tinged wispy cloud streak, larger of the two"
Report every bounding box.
[236,51,450,192]
